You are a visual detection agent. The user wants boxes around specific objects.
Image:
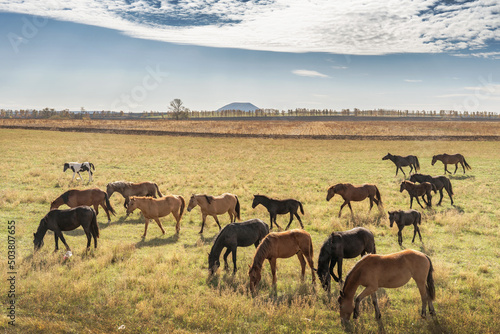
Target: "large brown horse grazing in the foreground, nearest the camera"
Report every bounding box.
[338,249,436,323]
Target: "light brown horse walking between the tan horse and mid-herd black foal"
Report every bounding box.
[187,193,241,233]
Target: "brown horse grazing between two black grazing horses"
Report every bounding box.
[248,229,316,293]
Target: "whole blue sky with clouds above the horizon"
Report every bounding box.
[0,0,500,113]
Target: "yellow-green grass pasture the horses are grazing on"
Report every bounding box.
[0,130,500,333]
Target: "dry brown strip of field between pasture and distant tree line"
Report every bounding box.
[0,119,500,141]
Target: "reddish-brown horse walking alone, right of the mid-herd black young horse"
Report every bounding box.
[326,183,382,219]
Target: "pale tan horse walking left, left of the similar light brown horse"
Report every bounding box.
[127,195,186,238]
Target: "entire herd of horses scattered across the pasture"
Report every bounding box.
[33,153,470,321]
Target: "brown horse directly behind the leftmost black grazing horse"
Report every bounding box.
[50,188,116,223]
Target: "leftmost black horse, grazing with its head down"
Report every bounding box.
[33,206,99,252]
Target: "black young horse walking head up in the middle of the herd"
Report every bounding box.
[252,195,304,230]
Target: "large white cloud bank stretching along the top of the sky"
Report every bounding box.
[0,0,500,56]
